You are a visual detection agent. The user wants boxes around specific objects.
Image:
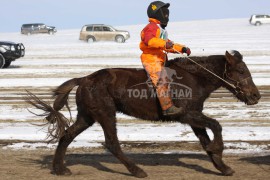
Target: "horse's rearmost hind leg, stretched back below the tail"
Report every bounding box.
[52,113,94,175]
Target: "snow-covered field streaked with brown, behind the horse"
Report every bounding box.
[0,19,270,153]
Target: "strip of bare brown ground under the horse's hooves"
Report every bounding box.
[0,142,270,180]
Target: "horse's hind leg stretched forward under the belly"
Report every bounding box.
[99,115,147,178]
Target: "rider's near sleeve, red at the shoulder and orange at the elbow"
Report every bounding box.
[141,23,166,49]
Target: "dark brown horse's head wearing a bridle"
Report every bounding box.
[224,51,261,105]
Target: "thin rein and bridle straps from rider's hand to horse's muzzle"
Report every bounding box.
[173,49,245,94]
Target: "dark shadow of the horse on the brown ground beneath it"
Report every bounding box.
[25,153,221,176]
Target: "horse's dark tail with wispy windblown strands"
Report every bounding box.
[25,78,81,142]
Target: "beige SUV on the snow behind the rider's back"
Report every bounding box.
[79,24,130,43]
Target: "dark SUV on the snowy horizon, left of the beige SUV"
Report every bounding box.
[21,23,57,35]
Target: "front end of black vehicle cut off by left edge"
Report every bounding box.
[0,41,25,68]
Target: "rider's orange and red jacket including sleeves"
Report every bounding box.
[140,18,184,63]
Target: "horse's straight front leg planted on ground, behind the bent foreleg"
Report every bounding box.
[191,126,234,176]
